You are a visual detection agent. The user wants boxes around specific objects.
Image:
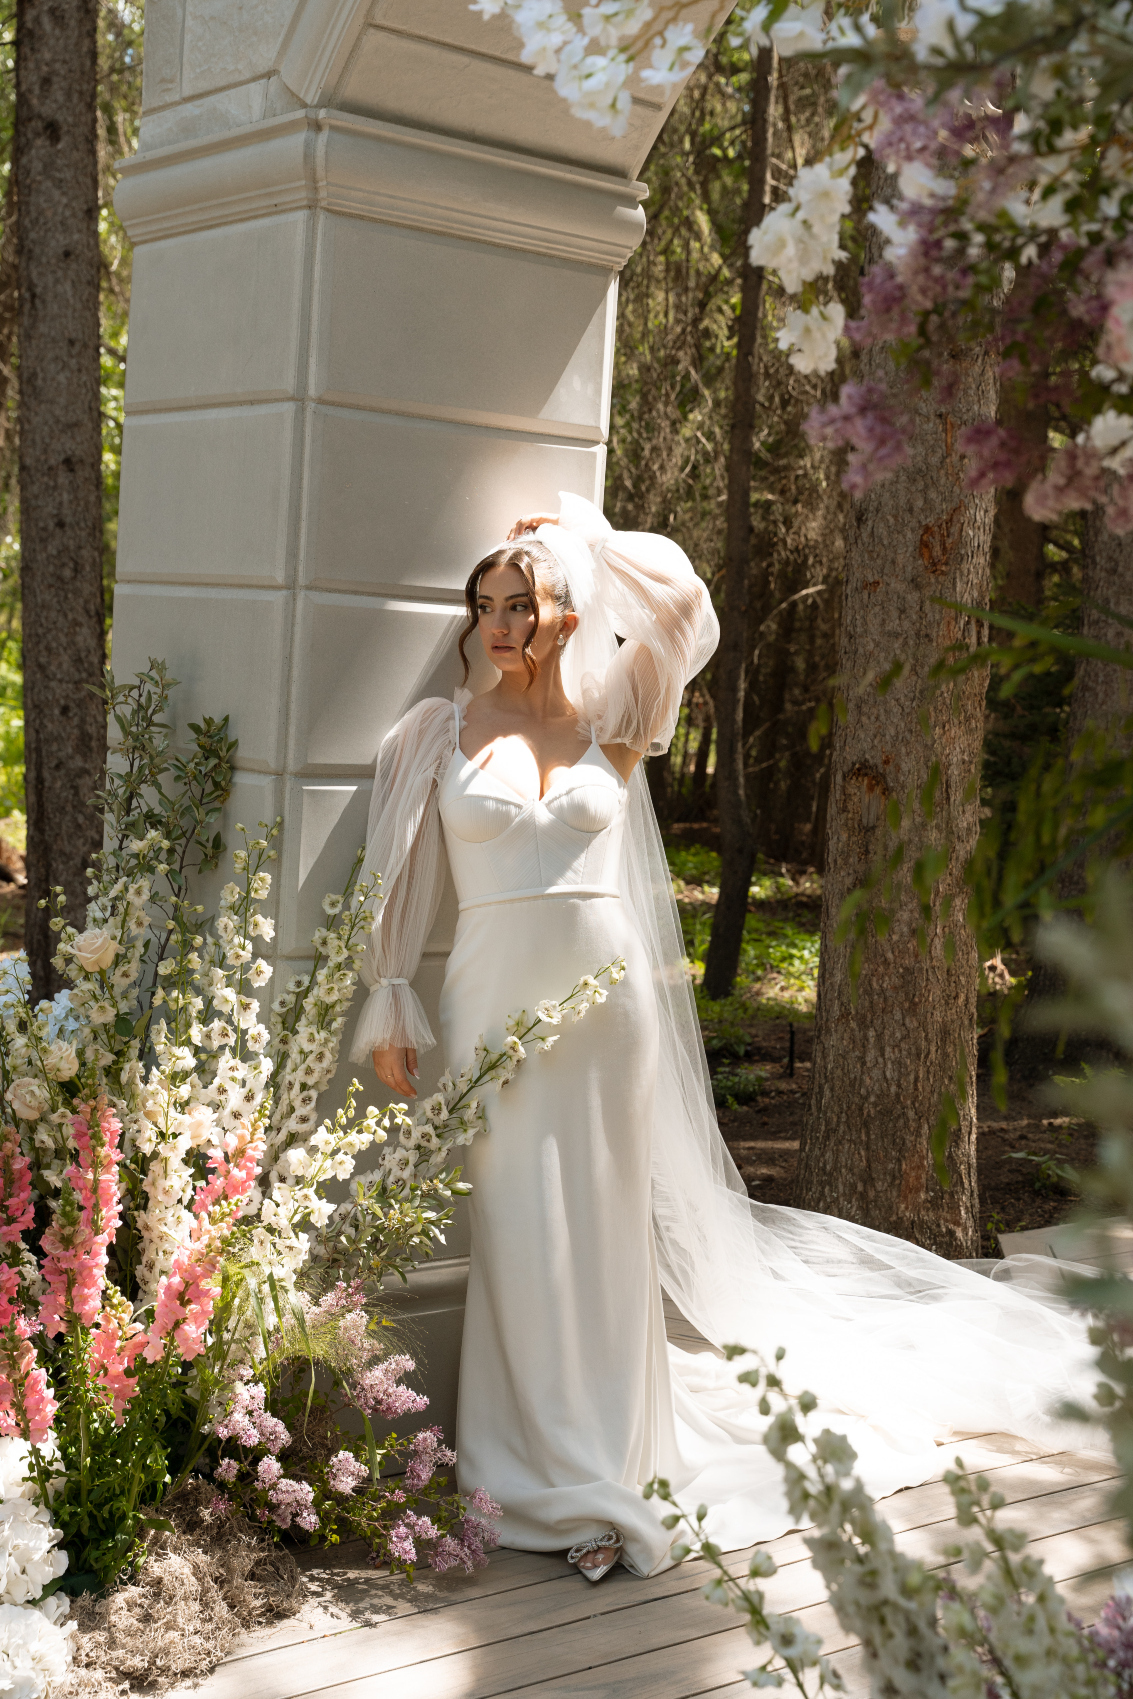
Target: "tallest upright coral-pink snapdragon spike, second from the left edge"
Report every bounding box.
[39,1098,122,1335]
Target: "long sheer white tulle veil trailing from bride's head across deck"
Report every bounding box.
[535,493,1108,1451]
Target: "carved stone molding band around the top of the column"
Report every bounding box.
[114,109,647,270]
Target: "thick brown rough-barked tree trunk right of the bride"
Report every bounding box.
[795,175,995,1257]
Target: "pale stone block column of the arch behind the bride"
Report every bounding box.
[114,0,710,1425]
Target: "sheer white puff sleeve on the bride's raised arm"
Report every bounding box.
[559,491,720,754]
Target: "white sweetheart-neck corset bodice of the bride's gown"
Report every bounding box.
[440,742,627,909]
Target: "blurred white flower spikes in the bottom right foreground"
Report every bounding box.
[645,1347,1133,1699]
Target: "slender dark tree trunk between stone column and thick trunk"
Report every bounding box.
[705,48,775,997]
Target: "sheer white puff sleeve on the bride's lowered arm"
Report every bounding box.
[350,697,457,1062]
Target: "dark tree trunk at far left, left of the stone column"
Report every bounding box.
[15,0,105,996]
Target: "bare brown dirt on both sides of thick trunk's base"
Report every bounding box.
[719,1021,1096,1257]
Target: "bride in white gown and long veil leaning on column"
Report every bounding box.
[352,494,1091,1580]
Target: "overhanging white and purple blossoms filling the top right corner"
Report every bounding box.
[472,0,1133,533]
